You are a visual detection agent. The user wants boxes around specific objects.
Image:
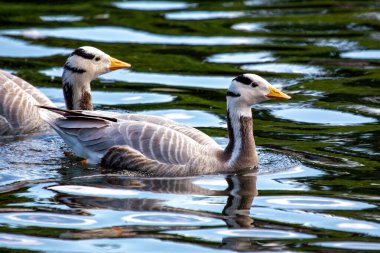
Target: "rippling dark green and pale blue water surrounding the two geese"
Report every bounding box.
[0,0,380,252]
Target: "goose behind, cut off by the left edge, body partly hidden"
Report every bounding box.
[0,46,131,136]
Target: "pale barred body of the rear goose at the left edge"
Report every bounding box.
[0,71,52,135]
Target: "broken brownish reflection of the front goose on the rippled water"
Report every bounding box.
[55,172,257,244]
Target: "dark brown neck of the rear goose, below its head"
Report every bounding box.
[62,69,94,111]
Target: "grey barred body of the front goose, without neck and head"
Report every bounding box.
[40,107,223,176]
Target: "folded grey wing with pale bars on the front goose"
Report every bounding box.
[40,106,220,165]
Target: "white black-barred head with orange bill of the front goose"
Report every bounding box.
[227,74,291,107]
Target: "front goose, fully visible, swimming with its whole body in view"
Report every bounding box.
[43,74,290,176]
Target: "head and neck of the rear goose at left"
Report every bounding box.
[62,46,131,110]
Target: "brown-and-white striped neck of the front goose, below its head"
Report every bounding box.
[224,98,258,169]
